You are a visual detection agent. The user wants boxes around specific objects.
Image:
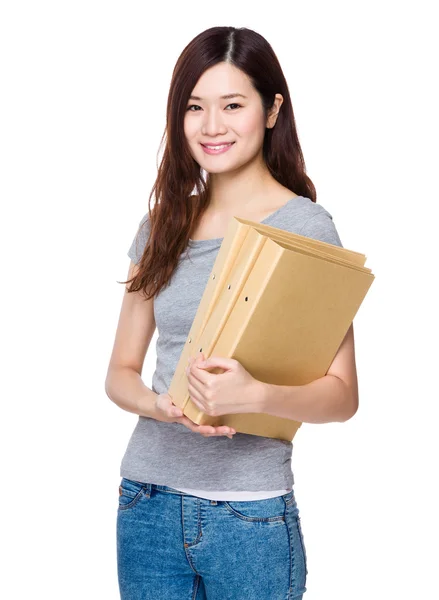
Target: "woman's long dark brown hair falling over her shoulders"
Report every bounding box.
[119,27,316,298]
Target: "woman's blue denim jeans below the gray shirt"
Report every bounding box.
[116,477,308,600]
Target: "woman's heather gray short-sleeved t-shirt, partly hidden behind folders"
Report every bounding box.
[120,196,342,491]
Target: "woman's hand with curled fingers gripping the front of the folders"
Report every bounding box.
[186,352,261,417]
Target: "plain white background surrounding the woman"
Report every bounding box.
[0,0,439,600]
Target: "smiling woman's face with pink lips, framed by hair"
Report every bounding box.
[184,62,272,173]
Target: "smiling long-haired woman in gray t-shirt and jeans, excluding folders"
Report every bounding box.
[106,27,358,600]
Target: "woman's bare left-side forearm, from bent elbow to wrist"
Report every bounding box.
[105,367,157,419]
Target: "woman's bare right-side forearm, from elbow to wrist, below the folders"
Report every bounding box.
[258,375,357,423]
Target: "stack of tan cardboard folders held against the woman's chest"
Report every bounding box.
[168,217,375,441]
